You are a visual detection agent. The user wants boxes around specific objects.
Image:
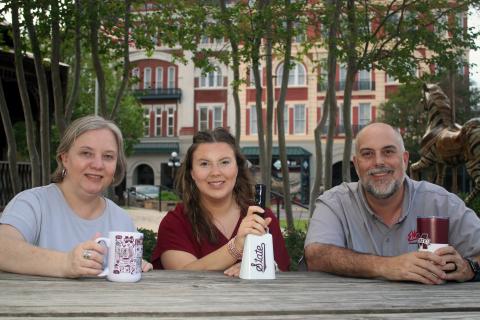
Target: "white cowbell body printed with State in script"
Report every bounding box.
[240,233,275,280]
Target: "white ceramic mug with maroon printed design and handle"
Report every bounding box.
[95,231,143,282]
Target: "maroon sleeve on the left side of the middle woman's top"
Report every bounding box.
[152,205,195,269]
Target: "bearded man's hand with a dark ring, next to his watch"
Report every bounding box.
[435,246,474,282]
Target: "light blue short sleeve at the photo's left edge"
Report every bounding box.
[0,190,42,244]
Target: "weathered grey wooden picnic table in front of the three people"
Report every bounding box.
[0,271,480,320]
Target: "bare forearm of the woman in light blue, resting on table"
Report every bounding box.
[0,234,65,277]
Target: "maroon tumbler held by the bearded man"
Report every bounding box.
[417,217,449,249]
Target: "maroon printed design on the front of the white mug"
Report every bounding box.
[113,235,143,274]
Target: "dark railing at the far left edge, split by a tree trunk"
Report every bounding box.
[0,161,32,212]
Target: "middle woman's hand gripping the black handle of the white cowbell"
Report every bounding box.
[235,206,272,252]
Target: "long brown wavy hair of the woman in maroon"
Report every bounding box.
[175,127,253,243]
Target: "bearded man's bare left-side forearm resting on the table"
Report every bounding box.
[305,243,388,278]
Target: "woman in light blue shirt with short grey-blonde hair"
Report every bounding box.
[0,116,152,278]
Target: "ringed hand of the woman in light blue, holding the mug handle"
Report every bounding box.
[64,233,106,278]
